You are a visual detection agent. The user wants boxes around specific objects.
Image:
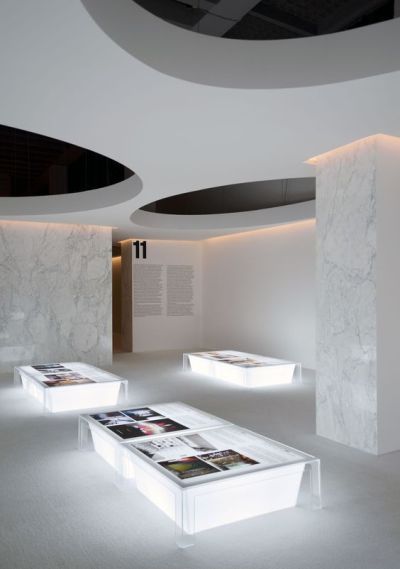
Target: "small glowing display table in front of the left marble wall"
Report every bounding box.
[14,362,128,413]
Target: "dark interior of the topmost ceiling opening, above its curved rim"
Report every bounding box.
[133,0,394,40]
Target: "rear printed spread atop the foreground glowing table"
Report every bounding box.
[90,403,225,440]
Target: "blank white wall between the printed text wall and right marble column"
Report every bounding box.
[203,220,316,368]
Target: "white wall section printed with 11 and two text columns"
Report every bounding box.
[132,239,202,352]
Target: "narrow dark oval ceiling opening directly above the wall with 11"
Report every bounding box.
[141,178,315,215]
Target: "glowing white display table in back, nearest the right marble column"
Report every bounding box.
[183,350,301,387]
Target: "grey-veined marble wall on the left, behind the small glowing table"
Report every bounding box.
[0,221,112,372]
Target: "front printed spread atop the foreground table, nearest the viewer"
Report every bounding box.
[130,426,304,480]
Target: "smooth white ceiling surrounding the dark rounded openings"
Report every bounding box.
[0,0,400,239]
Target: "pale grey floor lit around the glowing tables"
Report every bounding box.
[0,352,400,569]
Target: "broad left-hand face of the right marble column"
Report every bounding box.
[316,137,377,453]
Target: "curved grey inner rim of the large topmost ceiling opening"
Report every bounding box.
[81,0,400,90]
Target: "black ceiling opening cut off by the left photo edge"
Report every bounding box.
[0,125,133,197]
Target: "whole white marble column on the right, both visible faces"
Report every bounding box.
[310,135,400,454]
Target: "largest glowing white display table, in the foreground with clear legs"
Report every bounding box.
[79,403,321,547]
